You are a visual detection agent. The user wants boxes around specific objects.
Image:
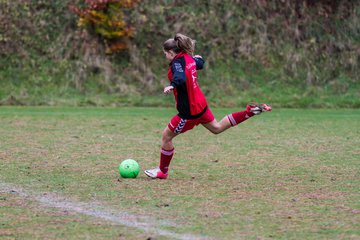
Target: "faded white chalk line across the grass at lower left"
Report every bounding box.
[0,182,210,240]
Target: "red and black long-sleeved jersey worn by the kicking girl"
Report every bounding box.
[168,52,207,119]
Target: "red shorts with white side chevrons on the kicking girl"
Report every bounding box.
[168,107,215,134]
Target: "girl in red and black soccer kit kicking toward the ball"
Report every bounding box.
[145,33,271,179]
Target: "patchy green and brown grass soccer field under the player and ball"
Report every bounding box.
[0,107,360,239]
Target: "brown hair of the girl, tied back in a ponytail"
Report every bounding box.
[163,33,195,56]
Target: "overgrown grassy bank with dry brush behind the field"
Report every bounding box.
[0,0,360,108]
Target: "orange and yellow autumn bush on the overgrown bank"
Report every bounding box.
[69,0,137,54]
